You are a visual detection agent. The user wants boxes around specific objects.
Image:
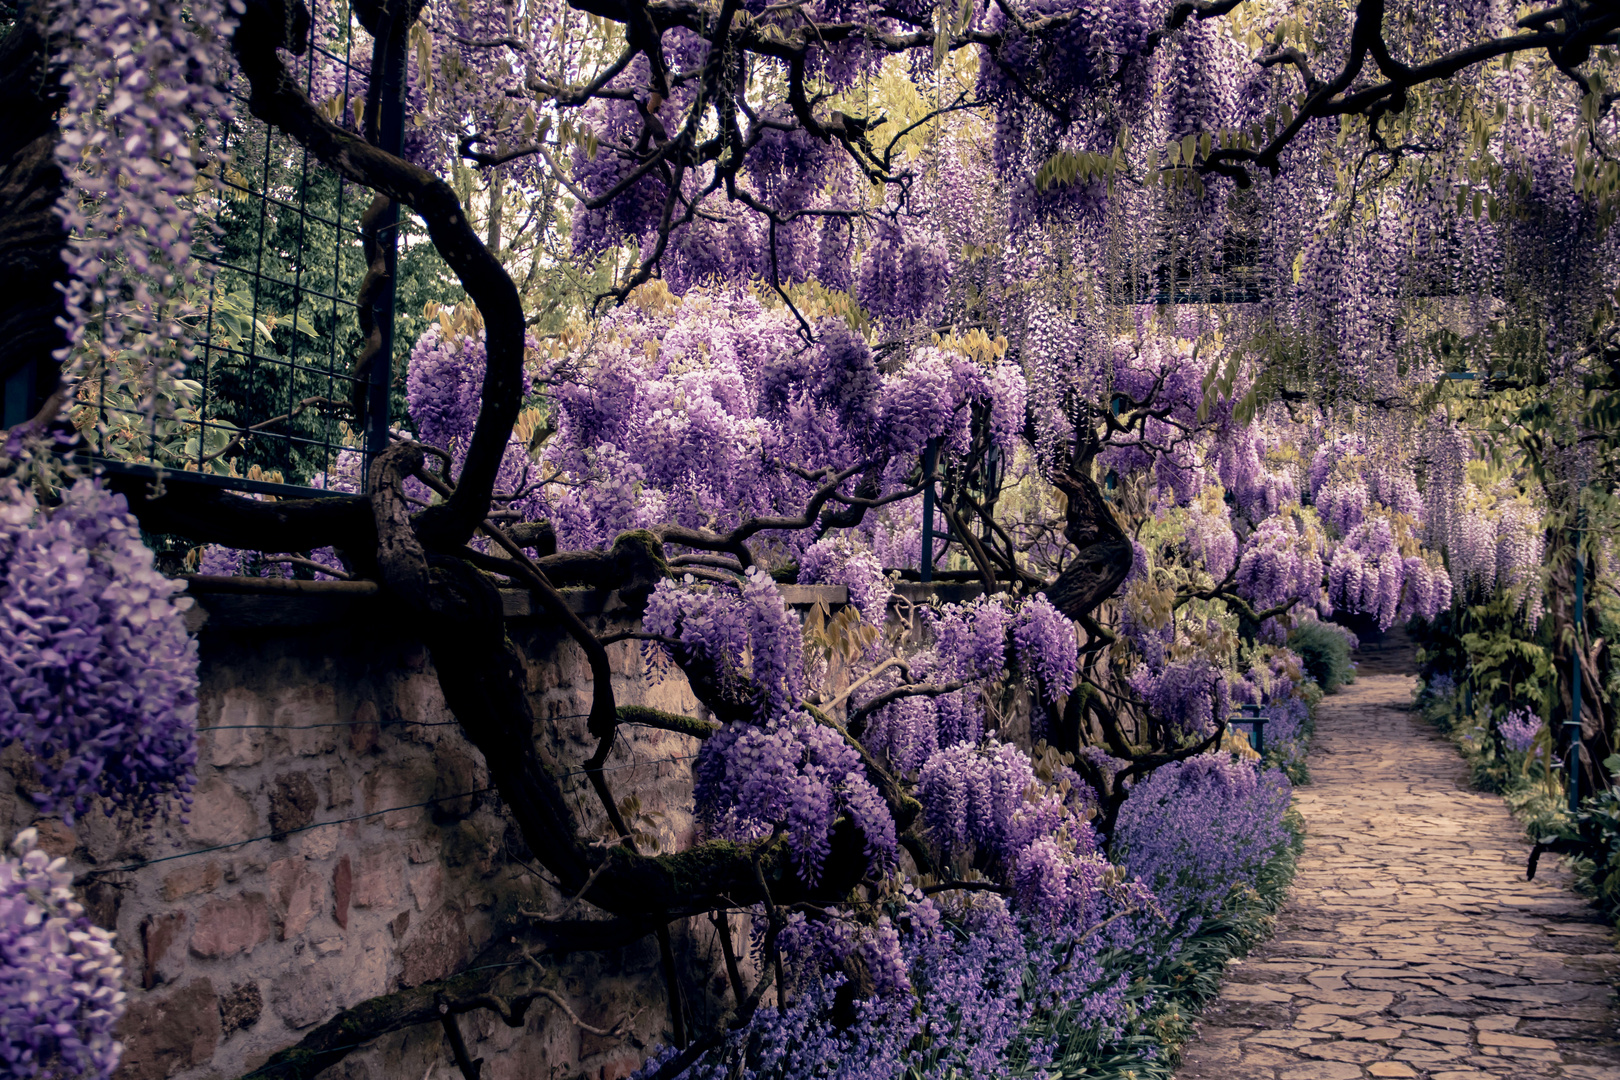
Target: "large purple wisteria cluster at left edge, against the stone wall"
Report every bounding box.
[0,479,198,821]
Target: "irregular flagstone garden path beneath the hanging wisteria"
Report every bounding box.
[1176,669,1620,1080]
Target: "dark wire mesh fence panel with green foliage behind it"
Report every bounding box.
[81,0,394,495]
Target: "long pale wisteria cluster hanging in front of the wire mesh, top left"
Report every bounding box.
[53,0,235,390]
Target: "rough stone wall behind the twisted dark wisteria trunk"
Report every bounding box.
[0,593,751,1080]
